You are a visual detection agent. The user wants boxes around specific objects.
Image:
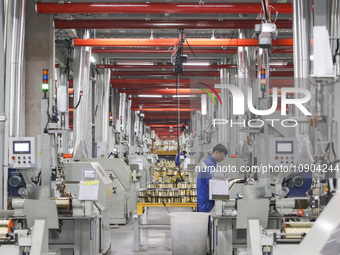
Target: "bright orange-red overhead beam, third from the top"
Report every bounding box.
[73,38,293,47]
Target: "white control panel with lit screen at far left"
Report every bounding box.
[8,137,35,169]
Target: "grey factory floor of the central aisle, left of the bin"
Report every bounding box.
[111,207,190,255]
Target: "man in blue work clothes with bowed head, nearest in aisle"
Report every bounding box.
[197,144,228,212]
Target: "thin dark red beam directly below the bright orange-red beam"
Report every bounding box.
[91,47,293,54]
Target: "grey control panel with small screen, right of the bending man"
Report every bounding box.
[269,137,297,166]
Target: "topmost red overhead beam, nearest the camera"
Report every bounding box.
[36,2,292,14]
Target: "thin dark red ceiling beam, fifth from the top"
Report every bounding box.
[96,65,237,69]
